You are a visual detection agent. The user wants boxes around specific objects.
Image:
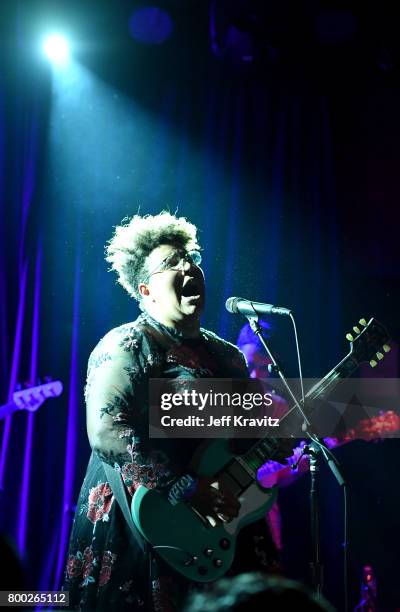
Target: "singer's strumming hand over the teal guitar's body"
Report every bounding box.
[190,476,240,524]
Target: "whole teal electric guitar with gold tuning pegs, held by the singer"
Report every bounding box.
[131,319,390,582]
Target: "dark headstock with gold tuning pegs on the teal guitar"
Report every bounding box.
[346,318,390,368]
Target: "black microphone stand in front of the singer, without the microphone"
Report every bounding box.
[247,314,347,607]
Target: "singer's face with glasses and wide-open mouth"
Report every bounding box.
[139,244,205,326]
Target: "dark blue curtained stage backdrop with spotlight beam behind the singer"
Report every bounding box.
[0,0,400,610]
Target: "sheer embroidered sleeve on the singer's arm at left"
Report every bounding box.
[85,330,184,493]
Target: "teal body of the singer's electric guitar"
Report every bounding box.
[132,440,277,582]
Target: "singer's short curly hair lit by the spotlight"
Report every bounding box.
[106,210,200,303]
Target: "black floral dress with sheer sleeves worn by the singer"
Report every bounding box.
[63,314,282,612]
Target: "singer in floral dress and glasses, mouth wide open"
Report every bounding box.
[64,212,282,612]
